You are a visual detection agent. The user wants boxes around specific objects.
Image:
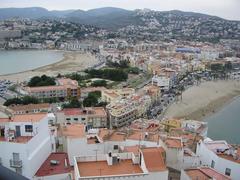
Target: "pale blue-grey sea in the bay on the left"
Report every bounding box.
[0,50,63,75]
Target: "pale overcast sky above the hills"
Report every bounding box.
[0,0,240,20]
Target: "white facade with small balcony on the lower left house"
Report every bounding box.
[0,116,52,179]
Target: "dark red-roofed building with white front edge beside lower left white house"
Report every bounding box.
[33,152,73,180]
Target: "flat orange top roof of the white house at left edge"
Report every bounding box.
[0,113,47,123]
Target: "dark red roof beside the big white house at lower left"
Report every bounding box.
[35,153,72,177]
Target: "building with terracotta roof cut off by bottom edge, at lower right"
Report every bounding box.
[180,167,231,180]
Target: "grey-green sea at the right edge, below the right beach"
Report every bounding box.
[204,97,240,144]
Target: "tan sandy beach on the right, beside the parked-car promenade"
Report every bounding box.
[164,80,240,120]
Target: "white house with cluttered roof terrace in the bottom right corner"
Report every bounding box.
[197,139,240,180]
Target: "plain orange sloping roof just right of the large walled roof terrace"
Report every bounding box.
[142,147,167,172]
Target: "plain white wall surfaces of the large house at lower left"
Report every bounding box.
[0,115,51,179]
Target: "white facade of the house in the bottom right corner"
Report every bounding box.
[197,141,240,180]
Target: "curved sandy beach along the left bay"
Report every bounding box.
[0,52,98,82]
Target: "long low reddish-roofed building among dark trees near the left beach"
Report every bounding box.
[25,78,81,99]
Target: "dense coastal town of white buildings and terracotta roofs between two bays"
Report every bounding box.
[0,7,240,180]
